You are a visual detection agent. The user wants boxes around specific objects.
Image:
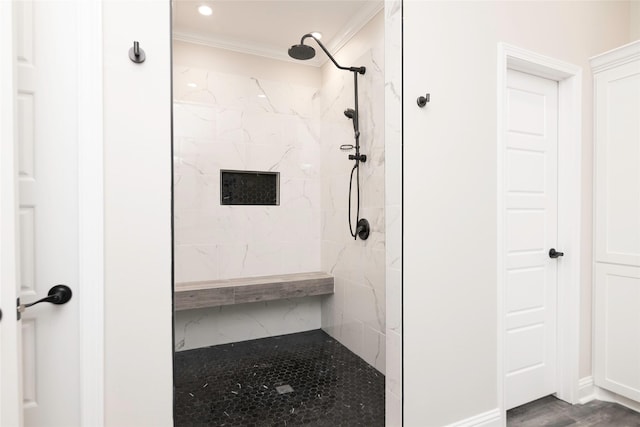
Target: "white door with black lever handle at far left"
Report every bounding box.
[0,1,80,427]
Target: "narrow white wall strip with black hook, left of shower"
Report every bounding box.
[103,0,173,427]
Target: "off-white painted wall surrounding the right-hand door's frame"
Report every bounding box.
[404,0,629,426]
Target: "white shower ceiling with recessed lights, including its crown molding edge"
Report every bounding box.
[173,0,383,66]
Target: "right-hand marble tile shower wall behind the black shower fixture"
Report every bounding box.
[315,42,386,373]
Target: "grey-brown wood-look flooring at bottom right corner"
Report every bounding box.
[507,396,640,427]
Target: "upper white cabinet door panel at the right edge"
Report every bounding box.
[595,61,640,265]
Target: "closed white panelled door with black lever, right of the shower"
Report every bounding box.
[503,70,562,409]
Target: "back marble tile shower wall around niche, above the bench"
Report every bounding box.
[174,66,320,282]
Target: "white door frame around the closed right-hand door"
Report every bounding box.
[496,43,582,425]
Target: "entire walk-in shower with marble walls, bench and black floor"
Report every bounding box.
[172,4,388,427]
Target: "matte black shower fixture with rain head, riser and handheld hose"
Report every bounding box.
[289,34,370,240]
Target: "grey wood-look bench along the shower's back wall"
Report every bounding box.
[174,272,333,311]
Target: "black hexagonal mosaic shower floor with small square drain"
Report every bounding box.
[174,330,384,427]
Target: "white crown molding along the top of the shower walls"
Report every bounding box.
[172,0,384,67]
